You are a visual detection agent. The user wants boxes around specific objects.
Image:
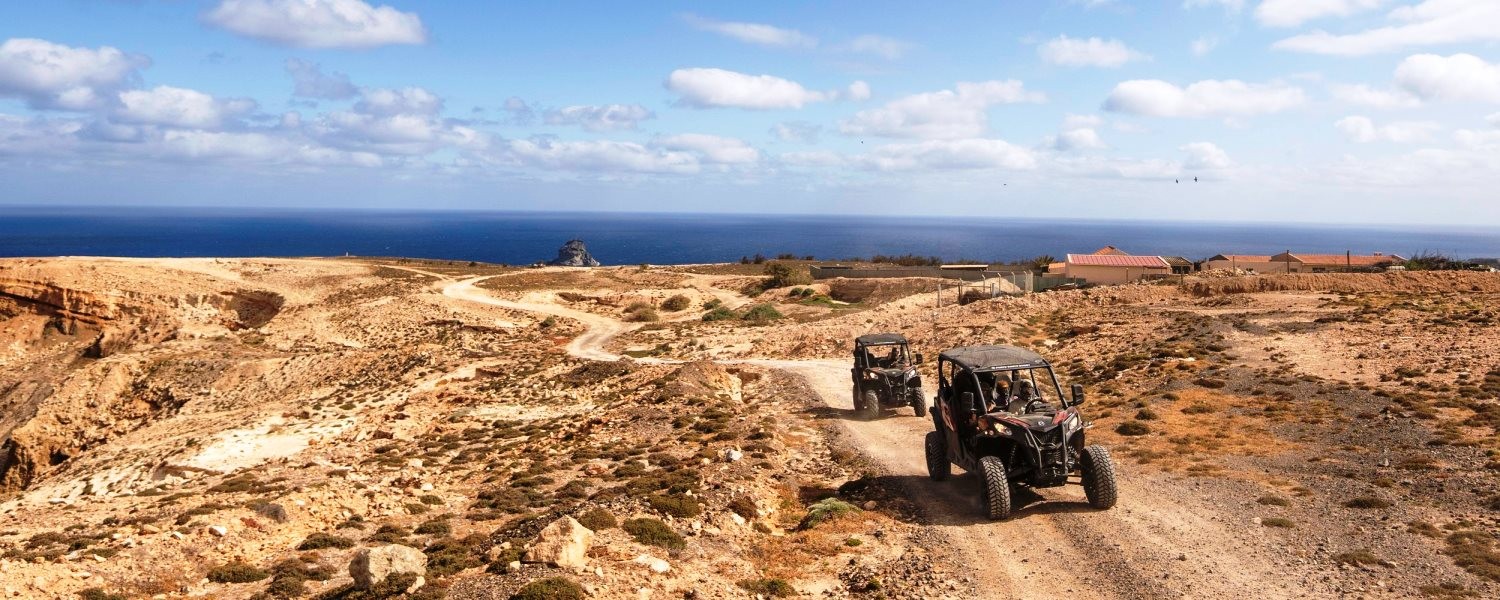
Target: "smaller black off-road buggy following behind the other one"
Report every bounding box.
[849,333,927,419]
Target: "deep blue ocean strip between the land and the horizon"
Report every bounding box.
[0,207,1500,264]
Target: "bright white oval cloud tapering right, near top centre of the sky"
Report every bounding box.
[666,68,836,110]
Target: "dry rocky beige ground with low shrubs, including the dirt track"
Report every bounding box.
[0,258,1500,599]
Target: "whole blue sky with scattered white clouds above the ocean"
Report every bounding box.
[0,0,1500,227]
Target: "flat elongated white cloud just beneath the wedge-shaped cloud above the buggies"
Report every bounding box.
[858,140,1037,171]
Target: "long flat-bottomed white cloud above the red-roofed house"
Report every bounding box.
[1104,80,1305,117]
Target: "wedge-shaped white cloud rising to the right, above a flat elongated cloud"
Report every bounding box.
[839,80,1046,140]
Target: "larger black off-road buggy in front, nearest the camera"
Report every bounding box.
[926,345,1115,519]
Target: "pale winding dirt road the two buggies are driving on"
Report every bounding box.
[443,278,1320,599]
